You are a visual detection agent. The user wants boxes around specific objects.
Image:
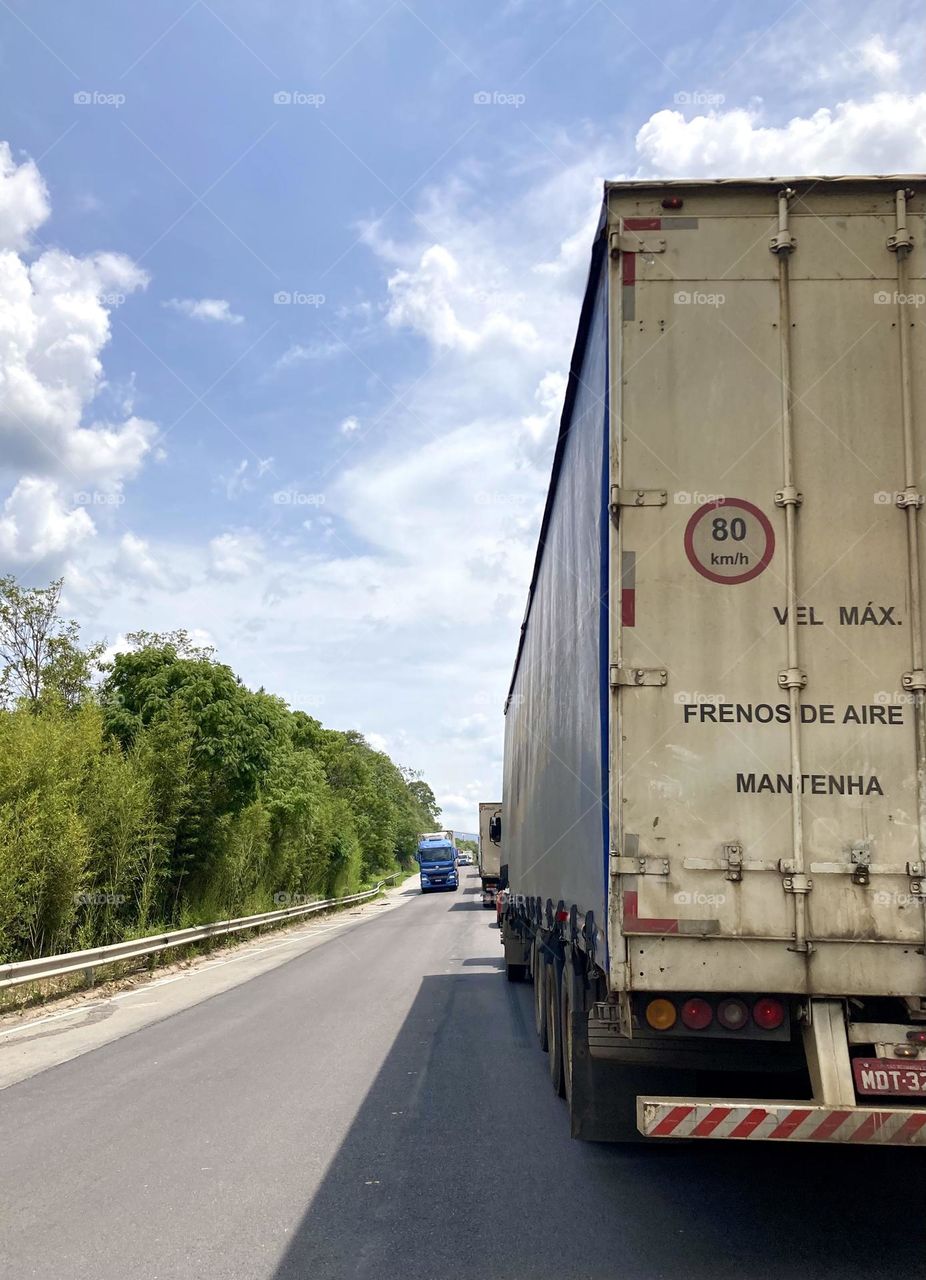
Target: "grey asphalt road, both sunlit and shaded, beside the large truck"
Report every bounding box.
[0,874,926,1280]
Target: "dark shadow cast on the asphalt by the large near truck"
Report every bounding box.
[275,957,923,1280]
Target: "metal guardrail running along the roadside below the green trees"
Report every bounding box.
[0,872,405,991]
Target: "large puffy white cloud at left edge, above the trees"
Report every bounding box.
[0,142,155,567]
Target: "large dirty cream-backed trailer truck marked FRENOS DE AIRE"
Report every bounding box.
[502,177,926,1144]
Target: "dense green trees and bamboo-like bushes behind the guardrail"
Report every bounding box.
[0,577,439,963]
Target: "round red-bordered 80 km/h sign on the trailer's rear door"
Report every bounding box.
[685,498,775,586]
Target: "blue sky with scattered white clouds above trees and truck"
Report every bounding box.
[0,0,926,831]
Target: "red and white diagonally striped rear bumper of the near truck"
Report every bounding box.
[637,1097,926,1147]
